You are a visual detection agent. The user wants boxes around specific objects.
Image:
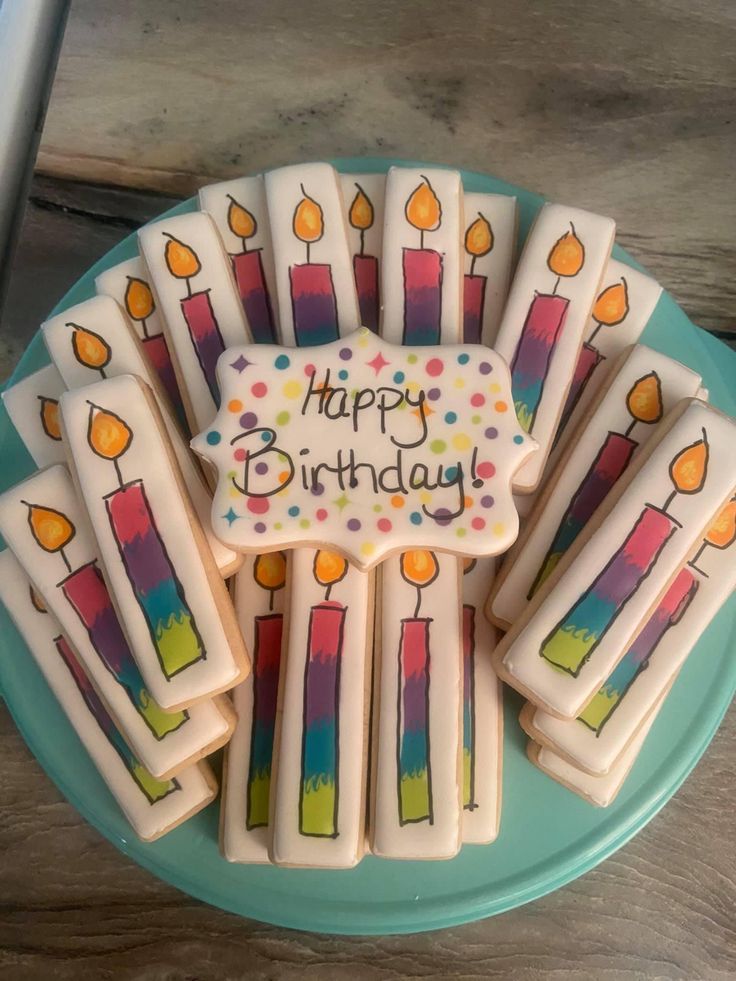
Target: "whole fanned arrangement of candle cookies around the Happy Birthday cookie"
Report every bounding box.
[0,163,736,869]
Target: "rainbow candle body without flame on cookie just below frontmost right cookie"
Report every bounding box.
[578,568,699,735]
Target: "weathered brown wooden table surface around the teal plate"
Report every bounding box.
[0,0,736,981]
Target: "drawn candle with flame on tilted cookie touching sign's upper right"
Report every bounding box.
[511,222,585,433]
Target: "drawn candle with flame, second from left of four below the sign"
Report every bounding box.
[299,549,348,838]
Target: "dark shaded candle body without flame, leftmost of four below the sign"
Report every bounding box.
[246,613,284,831]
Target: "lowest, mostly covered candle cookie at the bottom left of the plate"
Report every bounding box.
[0,549,217,841]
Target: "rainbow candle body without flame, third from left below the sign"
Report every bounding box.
[398,617,432,825]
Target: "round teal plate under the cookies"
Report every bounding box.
[0,159,736,934]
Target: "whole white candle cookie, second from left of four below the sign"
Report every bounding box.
[271,549,373,868]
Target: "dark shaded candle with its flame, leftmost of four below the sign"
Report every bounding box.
[246,552,286,831]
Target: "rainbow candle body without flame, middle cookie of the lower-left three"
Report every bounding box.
[60,562,189,739]
